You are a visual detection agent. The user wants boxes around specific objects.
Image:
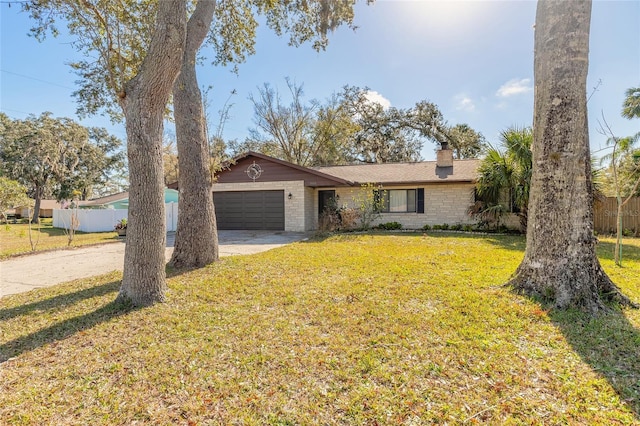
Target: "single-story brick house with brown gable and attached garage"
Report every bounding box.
[205,149,480,231]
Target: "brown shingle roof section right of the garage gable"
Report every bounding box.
[314,159,480,184]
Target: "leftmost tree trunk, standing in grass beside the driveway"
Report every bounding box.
[118,0,187,306]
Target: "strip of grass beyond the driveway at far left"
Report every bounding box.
[0,219,118,259]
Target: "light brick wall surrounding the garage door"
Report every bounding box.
[213,180,309,232]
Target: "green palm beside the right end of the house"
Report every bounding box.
[469,127,533,231]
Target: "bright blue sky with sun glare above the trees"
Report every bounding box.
[0,0,640,160]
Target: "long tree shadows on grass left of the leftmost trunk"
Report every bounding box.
[0,280,138,364]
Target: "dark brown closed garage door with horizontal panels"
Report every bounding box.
[213,191,284,231]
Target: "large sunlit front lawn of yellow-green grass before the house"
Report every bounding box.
[0,233,640,425]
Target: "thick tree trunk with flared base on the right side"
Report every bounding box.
[504,0,629,313]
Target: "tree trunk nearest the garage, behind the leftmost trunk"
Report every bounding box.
[170,0,218,268]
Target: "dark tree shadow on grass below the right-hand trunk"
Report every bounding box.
[549,310,640,420]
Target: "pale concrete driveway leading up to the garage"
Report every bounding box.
[0,231,309,297]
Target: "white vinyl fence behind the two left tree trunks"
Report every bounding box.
[53,203,178,232]
